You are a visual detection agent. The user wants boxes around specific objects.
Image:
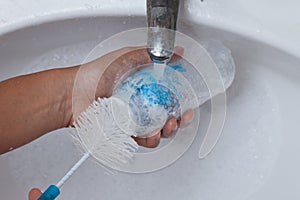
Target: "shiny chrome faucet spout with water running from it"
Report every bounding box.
[147,0,179,63]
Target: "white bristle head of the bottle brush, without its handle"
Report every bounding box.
[74,98,138,169]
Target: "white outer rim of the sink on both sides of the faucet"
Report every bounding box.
[0,0,300,56]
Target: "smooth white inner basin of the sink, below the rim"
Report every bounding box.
[0,11,300,200]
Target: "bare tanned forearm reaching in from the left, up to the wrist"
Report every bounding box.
[0,67,77,154]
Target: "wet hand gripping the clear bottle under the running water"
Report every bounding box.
[70,47,194,148]
